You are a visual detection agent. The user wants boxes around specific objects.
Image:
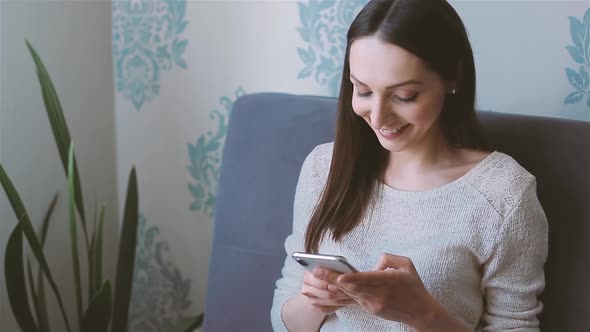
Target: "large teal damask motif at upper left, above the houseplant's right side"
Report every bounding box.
[112,0,188,110]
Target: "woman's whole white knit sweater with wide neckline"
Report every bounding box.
[271,143,548,331]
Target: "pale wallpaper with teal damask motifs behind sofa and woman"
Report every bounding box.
[112,0,590,331]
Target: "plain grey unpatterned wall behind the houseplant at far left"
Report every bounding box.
[0,0,118,331]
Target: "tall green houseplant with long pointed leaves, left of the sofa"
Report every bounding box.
[0,42,203,332]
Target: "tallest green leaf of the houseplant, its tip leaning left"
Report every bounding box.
[25,41,89,251]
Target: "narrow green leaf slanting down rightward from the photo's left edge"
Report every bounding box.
[0,163,71,332]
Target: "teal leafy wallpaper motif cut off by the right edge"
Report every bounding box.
[564,8,590,107]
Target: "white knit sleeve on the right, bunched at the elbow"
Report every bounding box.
[482,180,548,331]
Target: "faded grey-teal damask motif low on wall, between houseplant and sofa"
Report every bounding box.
[129,214,191,332]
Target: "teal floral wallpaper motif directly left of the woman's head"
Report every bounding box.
[297,0,368,96]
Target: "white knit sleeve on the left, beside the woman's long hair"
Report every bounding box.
[271,146,325,331]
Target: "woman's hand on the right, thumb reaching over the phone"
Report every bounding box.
[322,254,465,331]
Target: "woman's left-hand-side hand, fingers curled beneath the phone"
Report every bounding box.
[301,269,356,314]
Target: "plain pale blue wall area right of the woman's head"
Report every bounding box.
[451,0,590,121]
